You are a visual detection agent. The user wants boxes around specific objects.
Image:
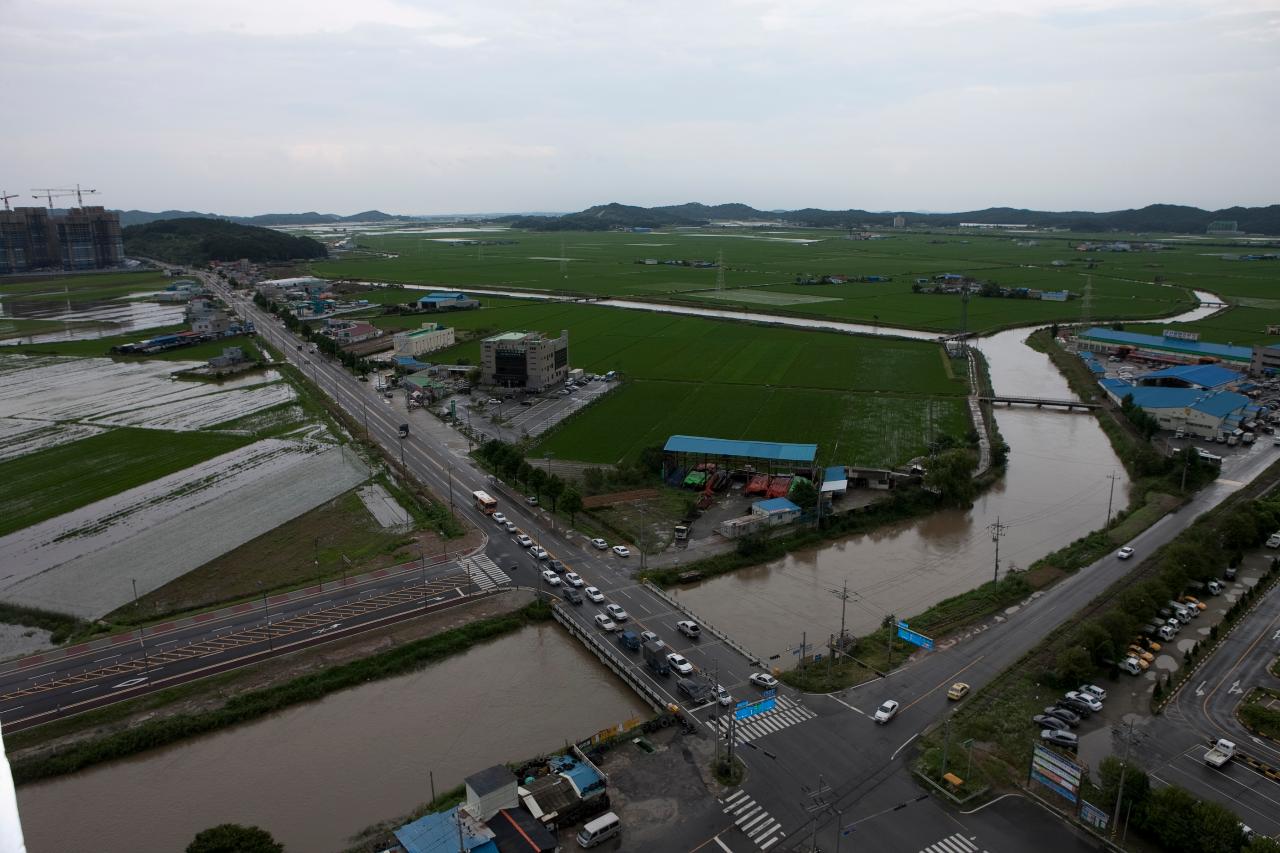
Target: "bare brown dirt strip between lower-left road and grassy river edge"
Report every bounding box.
[5,590,532,761]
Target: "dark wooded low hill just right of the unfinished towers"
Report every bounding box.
[123,216,328,264]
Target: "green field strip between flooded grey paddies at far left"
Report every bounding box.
[0,428,252,535]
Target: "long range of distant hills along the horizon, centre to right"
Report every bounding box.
[493,202,1280,234]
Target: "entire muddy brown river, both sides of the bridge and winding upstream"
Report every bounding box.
[18,293,1216,853]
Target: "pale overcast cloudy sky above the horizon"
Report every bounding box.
[0,0,1280,214]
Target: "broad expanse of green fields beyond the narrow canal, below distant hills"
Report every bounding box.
[312,229,1192,332]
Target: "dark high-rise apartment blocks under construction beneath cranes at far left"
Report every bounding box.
[0,207,124,273]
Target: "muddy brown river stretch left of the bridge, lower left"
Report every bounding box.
[18,625,648,853]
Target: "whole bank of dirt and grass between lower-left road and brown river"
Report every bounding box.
[5,590,550,785]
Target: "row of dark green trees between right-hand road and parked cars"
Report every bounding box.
[1052,498,1280,684]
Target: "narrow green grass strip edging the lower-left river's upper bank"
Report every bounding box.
[13,602,550,784]
